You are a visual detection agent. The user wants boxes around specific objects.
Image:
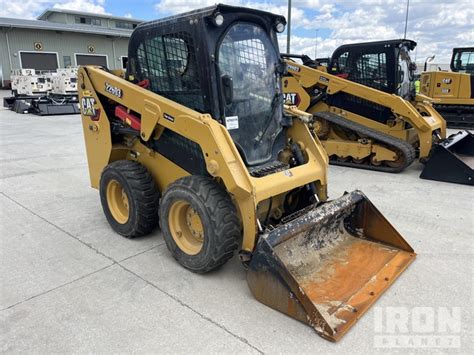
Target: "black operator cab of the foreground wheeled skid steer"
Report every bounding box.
[126,5,286,167]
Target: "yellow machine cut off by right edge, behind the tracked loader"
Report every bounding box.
[421,47,474,129]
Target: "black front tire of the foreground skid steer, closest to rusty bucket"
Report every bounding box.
[159,175,242,273]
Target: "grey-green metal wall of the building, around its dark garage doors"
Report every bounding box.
[0,28,129,80]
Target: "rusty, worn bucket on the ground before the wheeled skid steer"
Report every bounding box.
[247,191,416,341]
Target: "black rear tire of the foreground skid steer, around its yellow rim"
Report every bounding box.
[99,160,160,238]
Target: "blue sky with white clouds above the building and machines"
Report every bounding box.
[0,0,474,63]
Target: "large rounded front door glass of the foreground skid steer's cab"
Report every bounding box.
[218,23,283,165]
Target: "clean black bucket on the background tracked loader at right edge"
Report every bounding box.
[420,131,474,185]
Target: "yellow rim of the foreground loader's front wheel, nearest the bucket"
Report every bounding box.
[168,201,204,255]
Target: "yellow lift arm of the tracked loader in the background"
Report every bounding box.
[283,59,446,158]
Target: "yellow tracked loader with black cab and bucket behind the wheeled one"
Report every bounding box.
[282,40,474,185]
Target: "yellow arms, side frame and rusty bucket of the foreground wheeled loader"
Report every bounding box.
[79,67,415,341]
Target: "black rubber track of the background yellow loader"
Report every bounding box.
[314,112,416,173]
